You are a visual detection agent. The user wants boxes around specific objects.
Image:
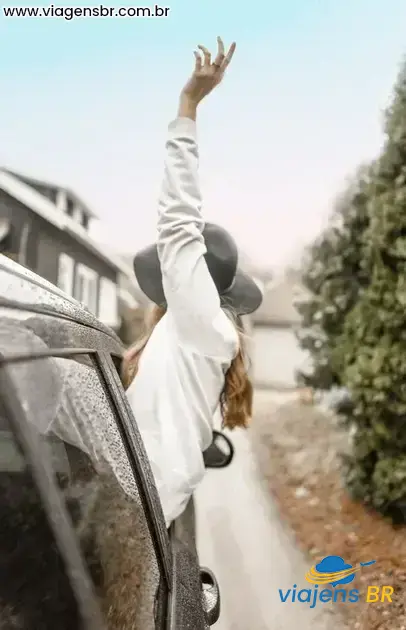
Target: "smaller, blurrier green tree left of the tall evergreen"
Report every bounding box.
[297,167,369,389]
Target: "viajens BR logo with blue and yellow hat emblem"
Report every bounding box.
[279,556,394,608]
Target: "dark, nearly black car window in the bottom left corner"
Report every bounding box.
[0,400,83,630]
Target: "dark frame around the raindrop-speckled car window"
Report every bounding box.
[0,344,172,608]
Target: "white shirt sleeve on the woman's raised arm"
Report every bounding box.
[158,118,238,356]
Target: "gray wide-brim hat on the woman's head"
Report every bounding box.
[134,223,263,315]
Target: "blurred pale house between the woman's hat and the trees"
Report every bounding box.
[251,272,309,389]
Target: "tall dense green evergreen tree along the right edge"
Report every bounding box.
[333,64,406,522]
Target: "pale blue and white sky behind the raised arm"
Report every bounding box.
[0,0,406,268]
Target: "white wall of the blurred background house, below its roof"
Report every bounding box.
[252,326,307,388]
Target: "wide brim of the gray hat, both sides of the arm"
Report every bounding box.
[134,245,263,315]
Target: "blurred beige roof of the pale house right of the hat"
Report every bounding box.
[252,275,302,326]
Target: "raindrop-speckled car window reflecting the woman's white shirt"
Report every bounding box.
[0,323,167,630]
